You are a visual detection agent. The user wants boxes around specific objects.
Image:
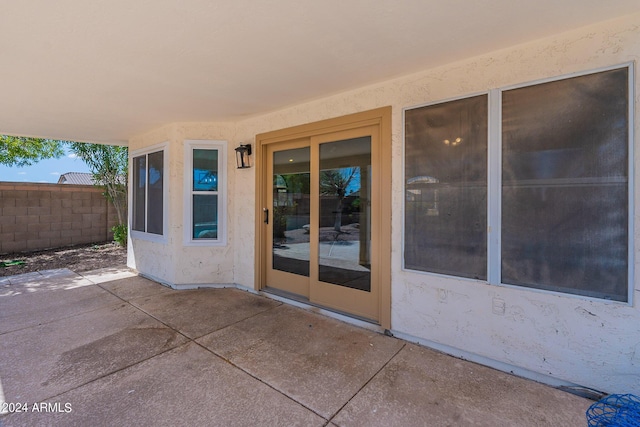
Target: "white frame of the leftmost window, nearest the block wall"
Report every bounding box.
[128,141,169,243]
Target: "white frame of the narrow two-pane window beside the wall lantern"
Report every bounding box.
[183,139,228,247]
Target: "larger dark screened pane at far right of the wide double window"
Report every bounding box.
[502,68,629,301]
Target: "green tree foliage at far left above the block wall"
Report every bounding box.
[0,135,68,167]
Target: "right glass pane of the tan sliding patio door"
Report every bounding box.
[318,137,371,292]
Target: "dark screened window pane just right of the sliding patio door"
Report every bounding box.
[404,95,488,279]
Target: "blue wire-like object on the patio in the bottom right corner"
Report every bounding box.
[587,394,640,427]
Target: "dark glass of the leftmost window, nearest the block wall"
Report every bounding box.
[131,145,166,237]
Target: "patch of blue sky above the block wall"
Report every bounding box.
[0,150,90,184]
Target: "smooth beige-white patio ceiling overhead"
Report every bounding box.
[0,0,640,143]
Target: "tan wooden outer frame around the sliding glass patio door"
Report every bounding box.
[254,107,392,329]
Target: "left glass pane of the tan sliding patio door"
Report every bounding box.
[271,147,311,277]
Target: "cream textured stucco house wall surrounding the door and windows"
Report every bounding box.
[131,14,640,393]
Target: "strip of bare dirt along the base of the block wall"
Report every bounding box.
[0,242,127,277]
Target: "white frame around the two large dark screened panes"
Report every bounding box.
[402,62,636,306]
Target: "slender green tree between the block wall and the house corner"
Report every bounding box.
[69,142,129,227]
